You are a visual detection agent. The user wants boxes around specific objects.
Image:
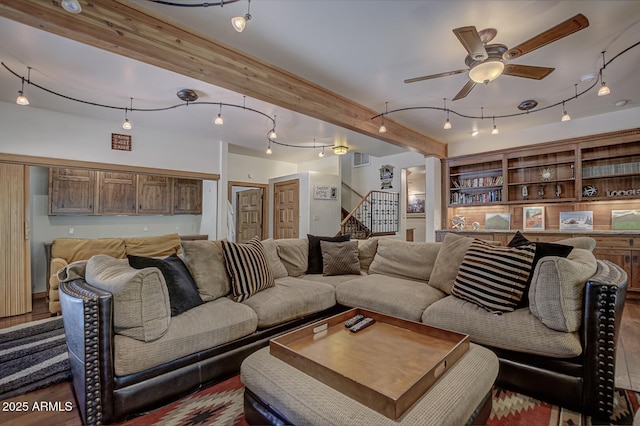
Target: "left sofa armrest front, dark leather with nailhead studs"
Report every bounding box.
[60,280,114,425]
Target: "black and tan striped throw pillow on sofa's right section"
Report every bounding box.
[451,240,536,314]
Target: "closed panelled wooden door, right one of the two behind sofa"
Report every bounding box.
[273,179,300,238]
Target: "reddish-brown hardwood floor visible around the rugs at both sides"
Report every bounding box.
[0,299,640,426]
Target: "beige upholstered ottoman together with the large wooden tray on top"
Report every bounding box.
[241,310,498,425]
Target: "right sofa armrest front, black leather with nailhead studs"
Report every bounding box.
[581,260,628,417]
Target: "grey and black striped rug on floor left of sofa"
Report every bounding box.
[0,317,71,400]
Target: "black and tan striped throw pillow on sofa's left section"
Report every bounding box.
[222,237,275,302]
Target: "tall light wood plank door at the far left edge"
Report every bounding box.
[0,163,31,317]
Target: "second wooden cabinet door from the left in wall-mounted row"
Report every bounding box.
[98,172,137,214]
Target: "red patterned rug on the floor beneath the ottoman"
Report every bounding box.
[121,376,640,426]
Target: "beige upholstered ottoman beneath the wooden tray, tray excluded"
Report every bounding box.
[240,344,498,426]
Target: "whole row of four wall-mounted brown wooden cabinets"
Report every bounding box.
[49,168,202,215]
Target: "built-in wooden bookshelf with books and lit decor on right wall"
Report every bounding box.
[442,128,640,232]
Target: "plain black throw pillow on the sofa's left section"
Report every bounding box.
[127,254,203,317]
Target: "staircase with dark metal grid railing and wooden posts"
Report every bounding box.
[338,185,400,240]
